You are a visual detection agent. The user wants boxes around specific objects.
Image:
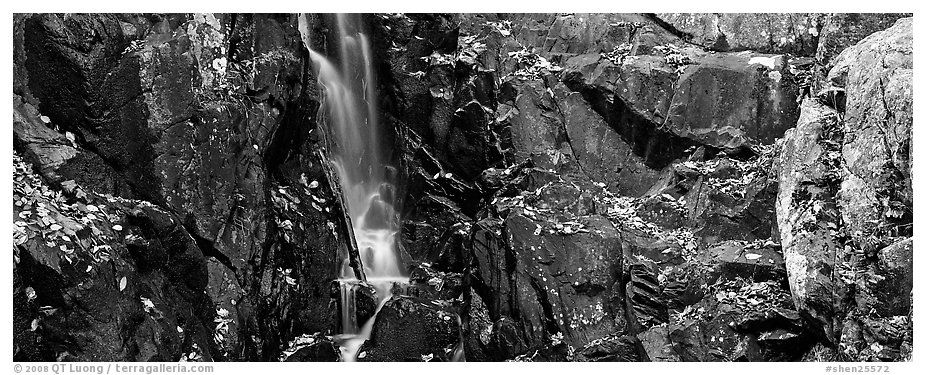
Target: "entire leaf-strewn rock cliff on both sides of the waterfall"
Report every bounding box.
[13,13,913,361]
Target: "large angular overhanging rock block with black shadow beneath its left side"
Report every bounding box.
[563,46,800,163]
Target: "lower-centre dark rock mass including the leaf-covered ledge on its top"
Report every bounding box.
[464,151,624,358]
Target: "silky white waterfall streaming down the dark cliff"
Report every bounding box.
[299,14,408,361]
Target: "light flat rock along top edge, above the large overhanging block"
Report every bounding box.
[655,13,823,56]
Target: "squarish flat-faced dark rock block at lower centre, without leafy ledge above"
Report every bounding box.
[474,214,622,354]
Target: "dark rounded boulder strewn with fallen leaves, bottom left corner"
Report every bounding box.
[13,156,217,361]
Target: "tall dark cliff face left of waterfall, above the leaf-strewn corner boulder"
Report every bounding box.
[14,14,354,360]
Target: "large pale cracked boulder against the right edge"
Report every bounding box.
[827,18,913,251]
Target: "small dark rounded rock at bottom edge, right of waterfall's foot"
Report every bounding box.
[357,296,460,362]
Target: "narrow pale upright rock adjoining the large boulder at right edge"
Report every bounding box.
[775,100,846,342]
